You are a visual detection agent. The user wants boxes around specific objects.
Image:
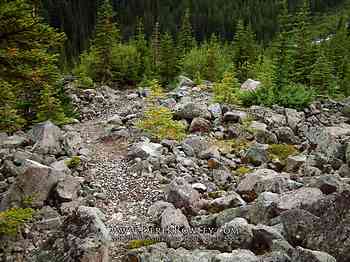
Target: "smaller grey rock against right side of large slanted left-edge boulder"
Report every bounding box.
[56,175,81,202]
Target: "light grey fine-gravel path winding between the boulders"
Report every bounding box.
[76,106,162,261]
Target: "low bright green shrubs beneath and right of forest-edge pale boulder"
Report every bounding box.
[239,84,315,110]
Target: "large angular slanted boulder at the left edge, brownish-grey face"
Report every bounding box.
[0,160,63,210]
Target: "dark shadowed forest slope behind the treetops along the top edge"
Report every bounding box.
[42,0,345,62]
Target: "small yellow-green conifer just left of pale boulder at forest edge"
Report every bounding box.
[214,71,240,104]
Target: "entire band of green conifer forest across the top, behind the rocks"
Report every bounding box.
[0,0,350,131]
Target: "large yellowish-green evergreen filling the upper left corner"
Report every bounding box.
[0,0,64,129]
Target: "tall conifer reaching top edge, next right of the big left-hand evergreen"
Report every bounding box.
[93,0,120,84]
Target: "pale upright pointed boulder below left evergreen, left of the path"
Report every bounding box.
[29,121,62,155]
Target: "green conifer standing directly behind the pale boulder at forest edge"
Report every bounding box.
[233,20,257,82]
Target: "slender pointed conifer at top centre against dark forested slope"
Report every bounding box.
[178,8,196,57]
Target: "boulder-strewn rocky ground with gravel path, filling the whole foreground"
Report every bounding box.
[0,77,350,262]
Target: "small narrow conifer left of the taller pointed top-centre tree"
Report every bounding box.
[159,32,177,83]
